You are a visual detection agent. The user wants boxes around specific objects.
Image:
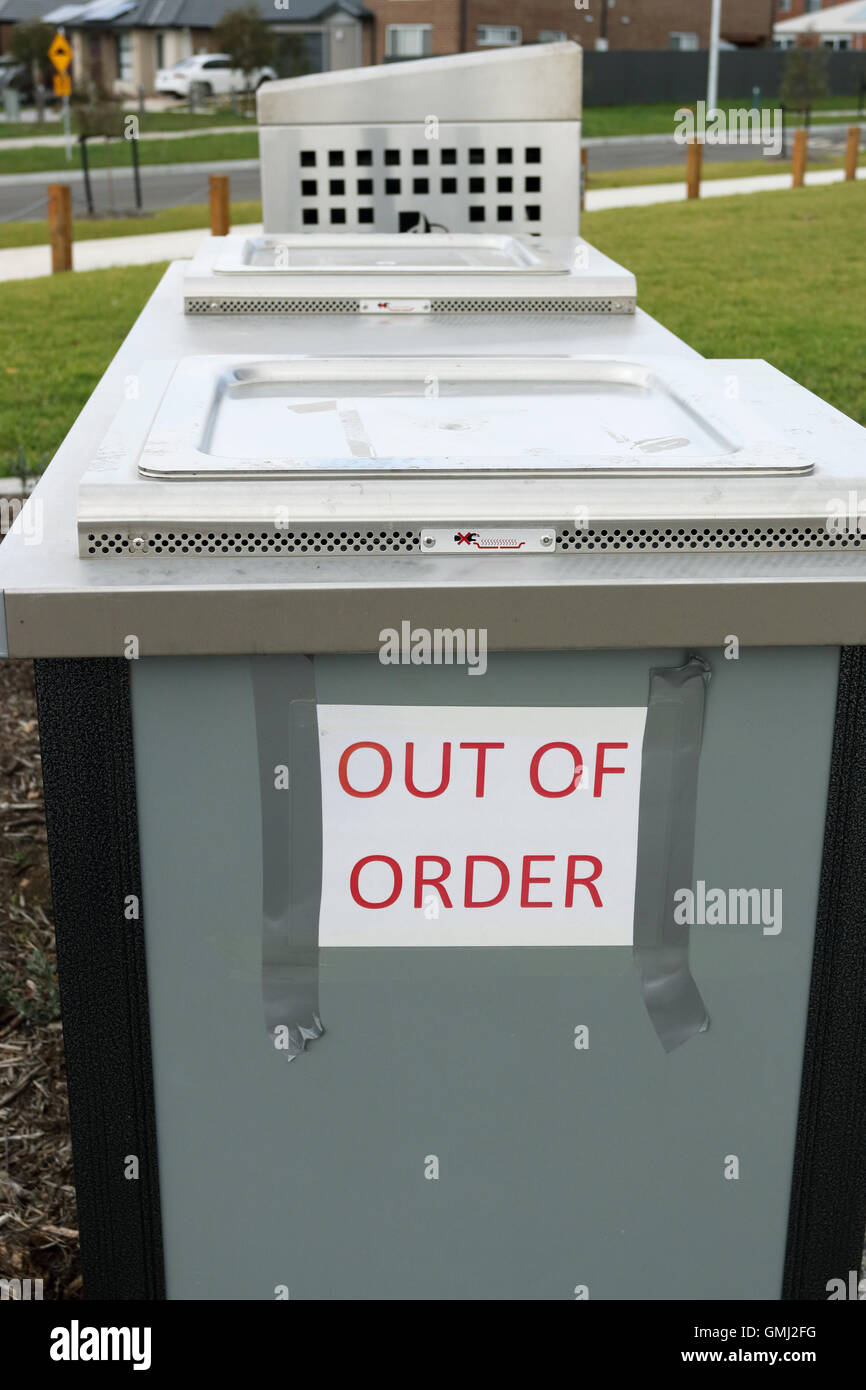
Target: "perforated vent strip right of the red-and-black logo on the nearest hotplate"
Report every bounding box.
[557,523,866,552]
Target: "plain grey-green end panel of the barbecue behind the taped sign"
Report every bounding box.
[131,644,838,1301]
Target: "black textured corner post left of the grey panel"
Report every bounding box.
[35,659,165,1300]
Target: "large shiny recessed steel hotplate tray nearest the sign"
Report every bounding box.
[138,356,812,481]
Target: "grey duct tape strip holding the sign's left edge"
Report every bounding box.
[250,656,325,1061]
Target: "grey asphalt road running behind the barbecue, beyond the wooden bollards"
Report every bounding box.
[0,125,848,221]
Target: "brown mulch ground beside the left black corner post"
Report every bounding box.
[0,662,82,1300]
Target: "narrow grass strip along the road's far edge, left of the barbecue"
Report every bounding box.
[0,128,259,174]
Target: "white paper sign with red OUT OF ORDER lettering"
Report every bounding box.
[318,705,646,947]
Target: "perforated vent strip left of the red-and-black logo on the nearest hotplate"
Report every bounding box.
[86,528,421,555]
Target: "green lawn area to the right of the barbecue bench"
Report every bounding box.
[581,182,866,424]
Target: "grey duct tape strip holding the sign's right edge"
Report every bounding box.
[634,656,712,1052]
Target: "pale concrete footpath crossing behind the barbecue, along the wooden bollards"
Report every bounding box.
[0,168,866,281]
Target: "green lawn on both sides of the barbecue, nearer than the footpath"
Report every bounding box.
[0,183,866,474]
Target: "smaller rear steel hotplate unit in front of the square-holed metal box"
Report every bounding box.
[183,232,637,314]
